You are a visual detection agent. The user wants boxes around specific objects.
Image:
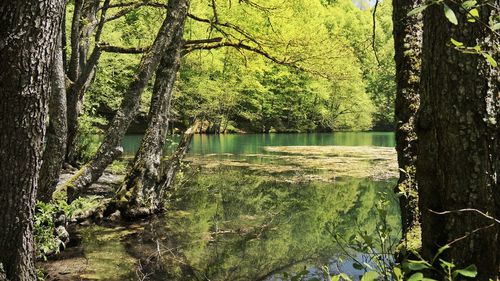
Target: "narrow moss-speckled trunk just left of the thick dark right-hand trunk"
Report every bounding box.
[393,0,423,250]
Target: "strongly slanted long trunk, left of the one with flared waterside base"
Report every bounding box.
[66,0,189,202]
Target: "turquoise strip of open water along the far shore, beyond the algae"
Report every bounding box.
[123,132,396,155]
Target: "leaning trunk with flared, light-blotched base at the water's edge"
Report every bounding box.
[117,13,187,216]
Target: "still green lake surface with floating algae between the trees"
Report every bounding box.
[46,133,400,281]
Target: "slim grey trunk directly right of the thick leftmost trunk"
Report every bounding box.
[37,25,68,202]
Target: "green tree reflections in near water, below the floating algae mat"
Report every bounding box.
[73,168,398,280]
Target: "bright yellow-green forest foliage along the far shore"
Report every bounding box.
[83,0,395,138]
